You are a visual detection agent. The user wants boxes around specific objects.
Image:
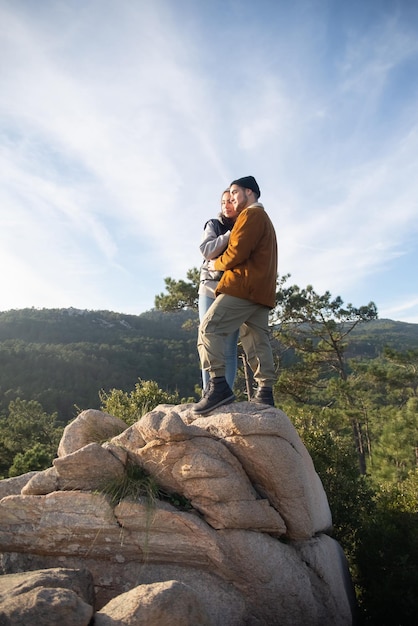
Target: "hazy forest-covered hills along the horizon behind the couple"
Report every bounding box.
[0,308,418,422]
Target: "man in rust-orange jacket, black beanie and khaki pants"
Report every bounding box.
[194,176,277,415]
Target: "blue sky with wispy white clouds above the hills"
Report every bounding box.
[0,0,418,323]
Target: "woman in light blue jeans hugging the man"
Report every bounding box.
[199,189,239,389]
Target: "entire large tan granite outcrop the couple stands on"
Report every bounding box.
[0,402,353,626]
